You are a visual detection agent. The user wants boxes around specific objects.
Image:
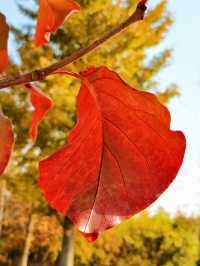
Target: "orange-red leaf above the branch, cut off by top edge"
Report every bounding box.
[35,0,80,47]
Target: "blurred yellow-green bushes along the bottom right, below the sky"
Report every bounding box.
[75,210,199,266]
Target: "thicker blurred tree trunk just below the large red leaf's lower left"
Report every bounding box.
[58,218,74,266]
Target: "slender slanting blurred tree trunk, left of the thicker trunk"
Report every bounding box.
[19,214,34,266]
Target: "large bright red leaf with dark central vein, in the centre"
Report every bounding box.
[39,67,185,240]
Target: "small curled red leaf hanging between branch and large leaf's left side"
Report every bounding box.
[25,83,52,142]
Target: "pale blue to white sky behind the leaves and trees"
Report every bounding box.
[0,0,200,214]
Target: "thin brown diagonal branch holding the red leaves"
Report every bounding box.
[0,1,146,89]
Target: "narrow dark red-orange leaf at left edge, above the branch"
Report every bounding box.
[0,13,9,73]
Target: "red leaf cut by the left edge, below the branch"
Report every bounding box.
[0,112,14,175]
